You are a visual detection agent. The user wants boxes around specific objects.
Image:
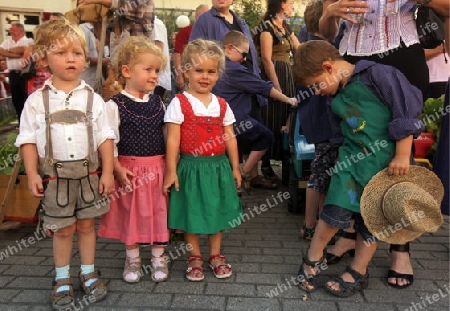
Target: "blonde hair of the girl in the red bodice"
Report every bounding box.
[181,39,225,78]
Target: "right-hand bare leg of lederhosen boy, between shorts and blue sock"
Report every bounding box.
[77,218,96,265]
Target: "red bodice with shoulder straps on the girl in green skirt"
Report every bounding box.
[176,94,227,156]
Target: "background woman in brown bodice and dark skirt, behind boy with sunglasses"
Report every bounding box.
[255,0,300,184]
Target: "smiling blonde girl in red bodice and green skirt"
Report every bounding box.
[163,39,242,281]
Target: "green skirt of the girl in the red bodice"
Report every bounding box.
[168,154,242,234]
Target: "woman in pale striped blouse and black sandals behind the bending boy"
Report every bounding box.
[319,0,429,288]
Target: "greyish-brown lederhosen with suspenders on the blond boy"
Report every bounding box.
[39,87,109,228]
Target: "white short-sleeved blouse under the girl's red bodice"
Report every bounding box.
[164,92,236,126]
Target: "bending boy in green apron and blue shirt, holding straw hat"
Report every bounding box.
[294,41,422,297]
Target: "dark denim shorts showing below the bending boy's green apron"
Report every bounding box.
[320,204,378,243]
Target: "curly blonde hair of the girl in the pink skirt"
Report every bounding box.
[115,36,168,88]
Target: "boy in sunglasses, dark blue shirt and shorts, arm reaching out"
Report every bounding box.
[213,30,297,189]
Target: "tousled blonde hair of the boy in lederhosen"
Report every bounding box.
[31,18,89,72]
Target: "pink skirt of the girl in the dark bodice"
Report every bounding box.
[98,156,169,245]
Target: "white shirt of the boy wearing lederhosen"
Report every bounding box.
[15,78,116,161]
